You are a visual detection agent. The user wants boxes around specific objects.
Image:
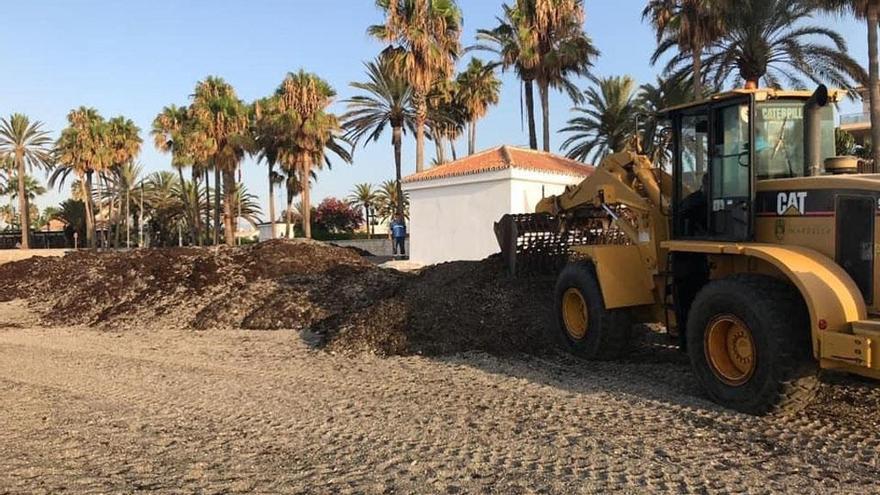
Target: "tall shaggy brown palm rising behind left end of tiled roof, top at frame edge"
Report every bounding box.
[367,0,462,172]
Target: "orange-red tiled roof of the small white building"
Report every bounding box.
[403,146,593,182]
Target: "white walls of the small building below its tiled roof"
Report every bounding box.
[405,169,582,264]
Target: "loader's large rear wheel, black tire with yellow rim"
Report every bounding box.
[687,275,818,415]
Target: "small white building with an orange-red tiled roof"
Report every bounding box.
[403,146,593,264]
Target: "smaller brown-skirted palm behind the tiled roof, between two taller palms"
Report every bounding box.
[457,58,501,155]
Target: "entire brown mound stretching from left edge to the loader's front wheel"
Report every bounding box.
[0,240,552,354]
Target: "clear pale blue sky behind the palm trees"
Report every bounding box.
[0,0,867,215]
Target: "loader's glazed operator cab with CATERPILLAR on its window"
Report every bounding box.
[665,87,836,242]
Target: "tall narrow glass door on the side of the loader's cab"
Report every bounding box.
[708,99,752,241]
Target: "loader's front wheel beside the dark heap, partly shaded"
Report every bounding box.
[555,262,633,360]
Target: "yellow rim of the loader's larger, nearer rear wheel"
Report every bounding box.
[704,315,756,386]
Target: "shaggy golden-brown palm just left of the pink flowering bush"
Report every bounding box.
[275,70,351,238]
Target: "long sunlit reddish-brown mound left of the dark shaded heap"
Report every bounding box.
[0,241,394,329]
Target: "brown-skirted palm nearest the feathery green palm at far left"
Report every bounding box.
[49,107,112,248]
